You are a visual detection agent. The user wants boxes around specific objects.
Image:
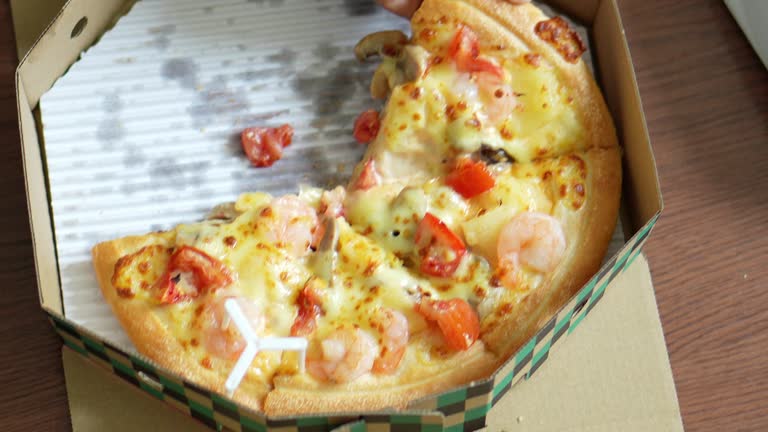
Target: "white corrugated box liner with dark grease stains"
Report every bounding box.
[40,0,624,351]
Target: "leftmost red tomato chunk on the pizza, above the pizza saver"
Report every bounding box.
[154,246,234,304]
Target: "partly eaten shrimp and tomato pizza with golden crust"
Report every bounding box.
[93,0,622,415]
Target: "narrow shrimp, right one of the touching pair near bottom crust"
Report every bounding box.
[373,308,408,374]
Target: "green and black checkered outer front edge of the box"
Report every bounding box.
[47,215,658,432]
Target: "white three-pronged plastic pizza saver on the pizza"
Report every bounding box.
[224,299,307,396]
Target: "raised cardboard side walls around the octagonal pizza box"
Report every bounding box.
[16,0,662,427]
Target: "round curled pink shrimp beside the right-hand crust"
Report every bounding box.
[497,212,566,286]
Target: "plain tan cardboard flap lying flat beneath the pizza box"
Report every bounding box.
[62,255,683,432]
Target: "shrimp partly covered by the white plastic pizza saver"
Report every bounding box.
[200,296,266,360]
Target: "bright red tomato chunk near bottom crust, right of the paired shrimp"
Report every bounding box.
[416,298,480,351]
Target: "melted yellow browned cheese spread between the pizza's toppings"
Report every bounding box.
[112,18,600,382]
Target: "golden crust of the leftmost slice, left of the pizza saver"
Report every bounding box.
[92,233,269,410]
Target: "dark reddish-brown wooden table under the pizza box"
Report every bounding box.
[0,0,768,431]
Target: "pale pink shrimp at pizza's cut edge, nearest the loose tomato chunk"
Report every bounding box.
[261,195,319,258]
